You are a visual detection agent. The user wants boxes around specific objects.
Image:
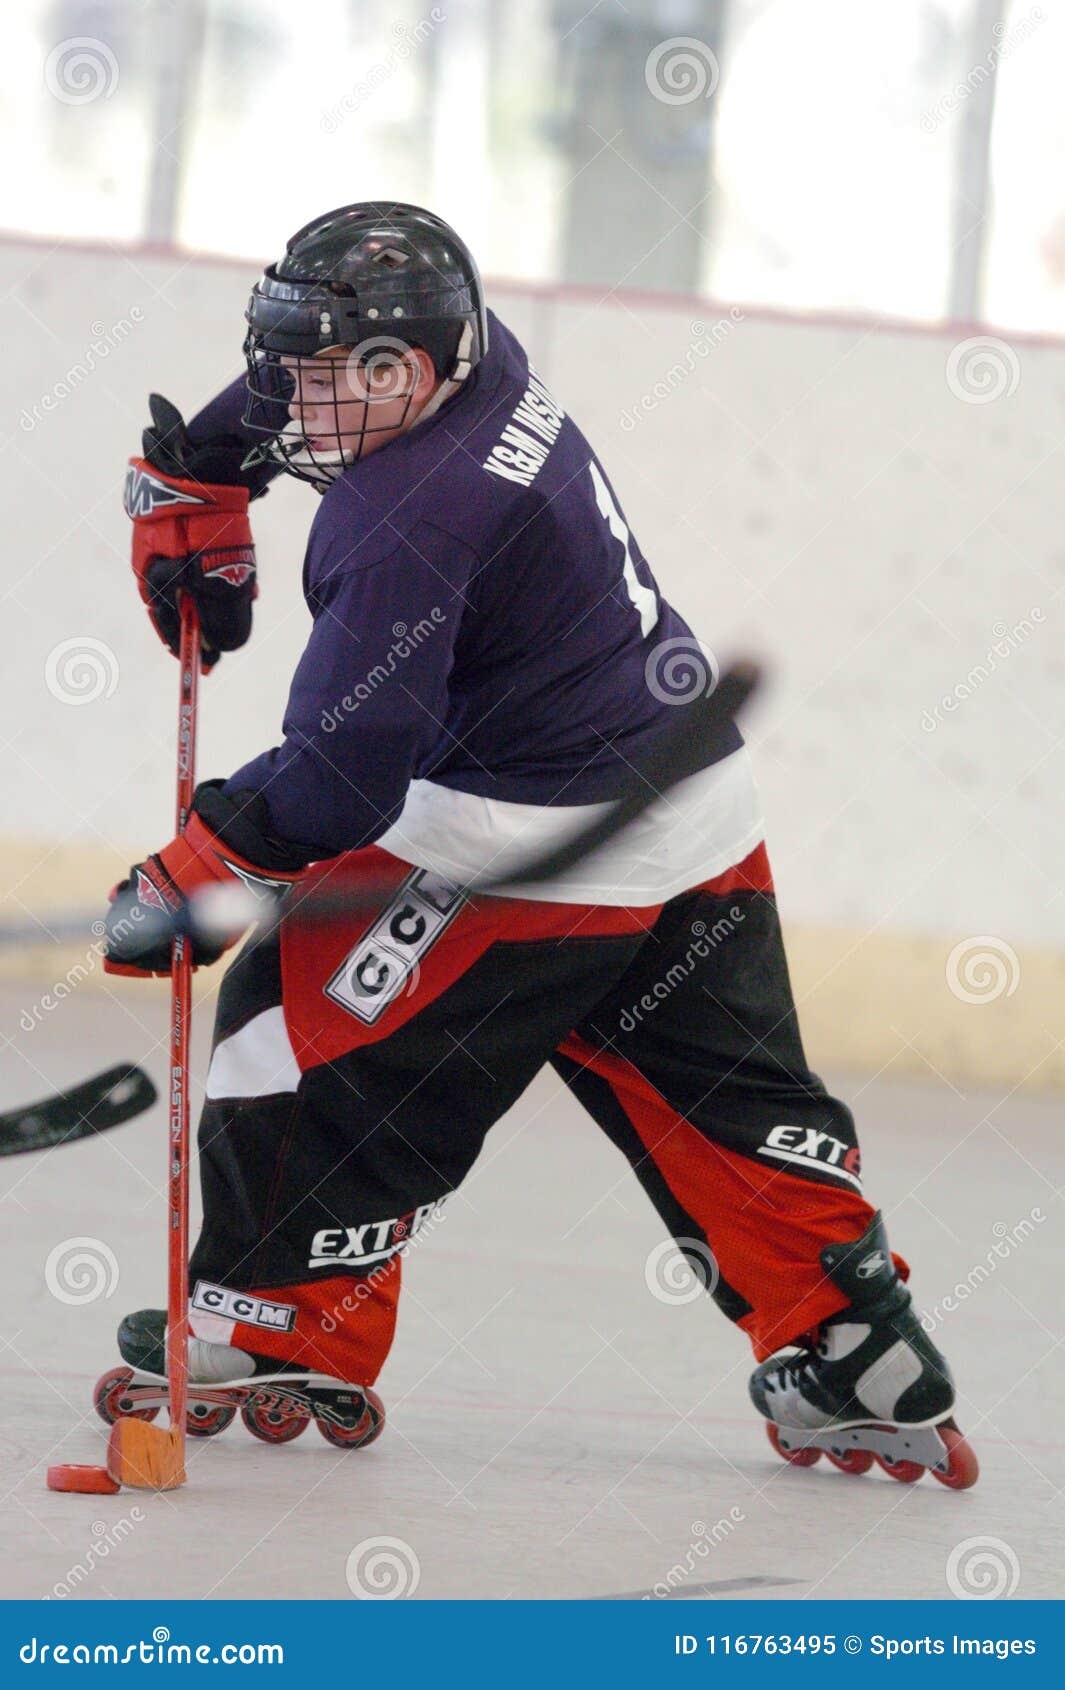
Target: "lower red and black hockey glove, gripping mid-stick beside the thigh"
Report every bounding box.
[103,781,306,979]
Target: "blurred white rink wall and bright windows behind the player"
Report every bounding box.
[0,0,1065,1088]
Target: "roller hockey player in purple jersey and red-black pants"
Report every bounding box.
[100,203,975,1486]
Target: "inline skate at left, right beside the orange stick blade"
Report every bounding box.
[93,1308,385,1450]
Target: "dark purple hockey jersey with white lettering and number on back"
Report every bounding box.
[191,313,759,896]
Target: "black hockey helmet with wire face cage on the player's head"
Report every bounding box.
[243,201,489,488]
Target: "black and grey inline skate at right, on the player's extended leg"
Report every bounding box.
[751,1213,980,1491]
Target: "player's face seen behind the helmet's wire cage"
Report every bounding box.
[281,346,436,458]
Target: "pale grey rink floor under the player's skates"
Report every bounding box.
[0,984,1065,1600]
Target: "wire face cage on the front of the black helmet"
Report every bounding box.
[243,331,421,492]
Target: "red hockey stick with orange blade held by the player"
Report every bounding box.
[107,597,199,1491]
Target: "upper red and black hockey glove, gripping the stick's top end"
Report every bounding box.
[125,394,257,669]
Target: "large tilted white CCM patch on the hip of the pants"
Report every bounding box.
[323,869,465,1026]
